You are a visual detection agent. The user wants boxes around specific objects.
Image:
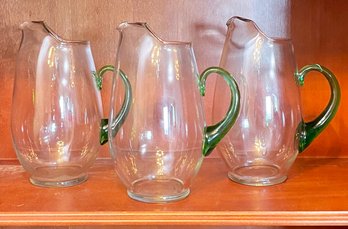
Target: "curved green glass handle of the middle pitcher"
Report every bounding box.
[199,67,240,156]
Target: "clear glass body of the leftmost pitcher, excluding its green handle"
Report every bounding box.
[11,22,102,186]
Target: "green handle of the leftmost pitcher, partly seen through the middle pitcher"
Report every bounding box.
[95,65,132,145]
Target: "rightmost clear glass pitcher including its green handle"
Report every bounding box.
[213,17,340,186]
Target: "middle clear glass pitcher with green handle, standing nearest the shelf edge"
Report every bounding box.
[108,22,239,202]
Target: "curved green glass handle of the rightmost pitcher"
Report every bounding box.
[295,64,341,153]
